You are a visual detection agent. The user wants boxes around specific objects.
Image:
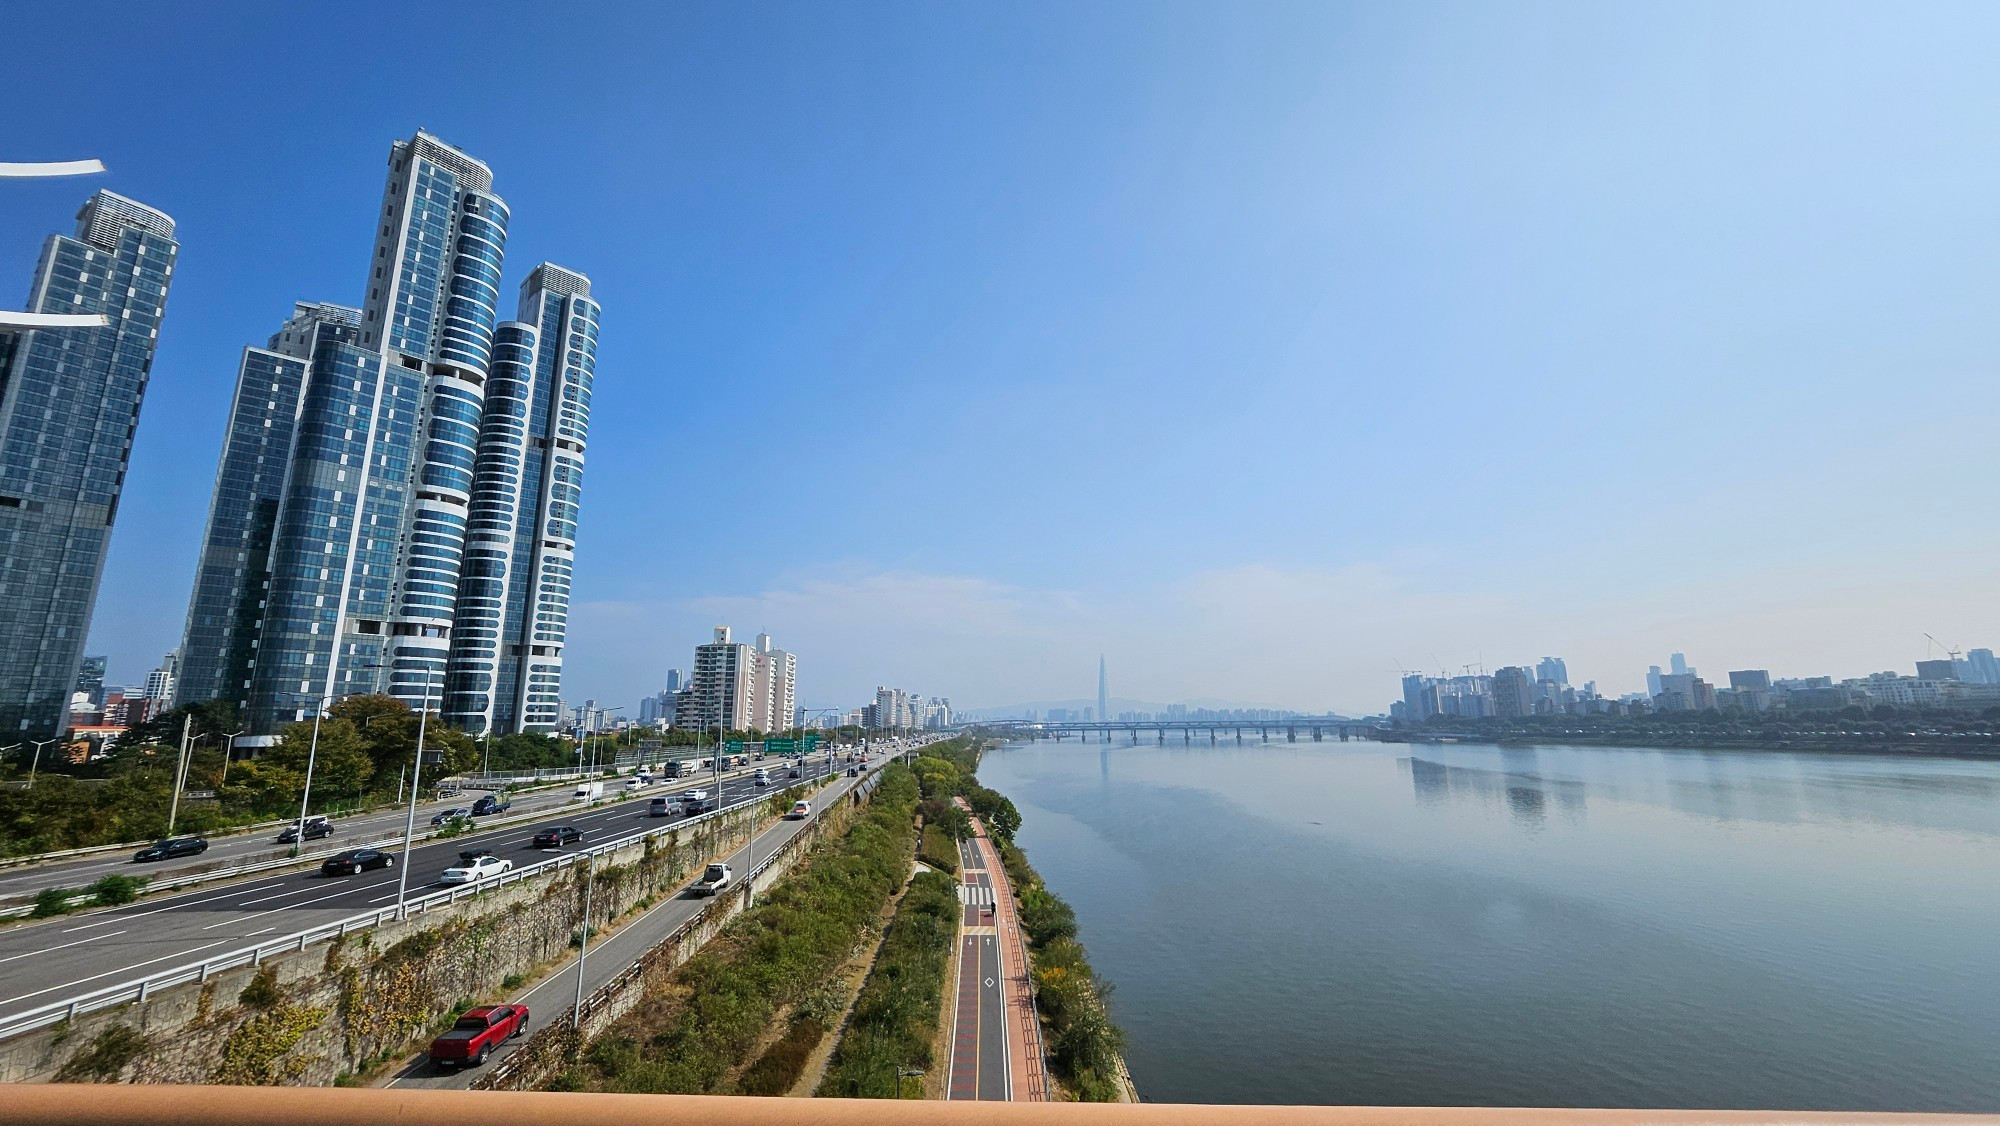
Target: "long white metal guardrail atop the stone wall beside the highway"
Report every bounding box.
[0,780,858,1040]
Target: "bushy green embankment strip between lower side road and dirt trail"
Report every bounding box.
[552,766,918,1094]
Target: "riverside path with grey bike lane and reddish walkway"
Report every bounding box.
[946,800,1048,1102]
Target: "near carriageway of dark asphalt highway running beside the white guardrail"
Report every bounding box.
[0,754,852,1016]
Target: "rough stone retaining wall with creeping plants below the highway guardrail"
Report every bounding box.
[0,784,804,1086]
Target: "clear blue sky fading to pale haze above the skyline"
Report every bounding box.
[0,2,2000,710]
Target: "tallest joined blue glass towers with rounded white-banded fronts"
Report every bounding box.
[180,132,596,736]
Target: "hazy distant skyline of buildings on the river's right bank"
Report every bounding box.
[1390,650,2000,722]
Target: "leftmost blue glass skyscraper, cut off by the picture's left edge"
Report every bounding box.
[0,192,180,736]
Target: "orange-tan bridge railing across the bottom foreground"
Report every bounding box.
[0,1084,2000,1126]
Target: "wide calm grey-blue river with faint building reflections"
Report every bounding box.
[980,742,2000,1112]
